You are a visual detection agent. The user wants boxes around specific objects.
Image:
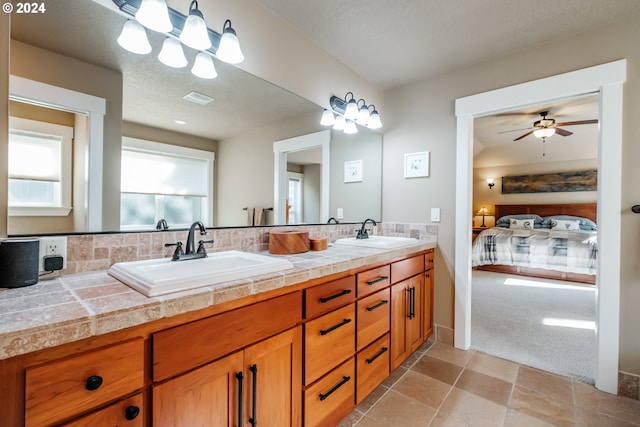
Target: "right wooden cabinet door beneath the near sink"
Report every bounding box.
[244,326,302,427]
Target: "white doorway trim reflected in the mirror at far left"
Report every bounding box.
[9,75,107,231]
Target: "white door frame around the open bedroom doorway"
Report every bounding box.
[454,59,627,394]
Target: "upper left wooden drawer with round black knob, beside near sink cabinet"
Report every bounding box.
[25,338,144,427]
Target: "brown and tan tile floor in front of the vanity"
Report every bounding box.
[339,341,640,427]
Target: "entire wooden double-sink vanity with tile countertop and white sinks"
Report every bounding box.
[0,236,436,427]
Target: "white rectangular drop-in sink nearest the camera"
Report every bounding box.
[108,251,293,297]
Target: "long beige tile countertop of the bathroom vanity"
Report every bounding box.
[0,237,436,359]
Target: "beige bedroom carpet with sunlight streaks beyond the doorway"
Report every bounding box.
[471,271,596,383]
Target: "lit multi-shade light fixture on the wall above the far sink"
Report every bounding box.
[320,92,382,134]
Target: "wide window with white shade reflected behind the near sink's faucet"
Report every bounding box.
[120,137,214,229]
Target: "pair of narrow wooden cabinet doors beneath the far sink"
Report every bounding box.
[391,274,424,371]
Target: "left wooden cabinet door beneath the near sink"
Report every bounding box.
[152,351,247,427]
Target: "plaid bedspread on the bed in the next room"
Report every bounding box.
[471,227,598,274]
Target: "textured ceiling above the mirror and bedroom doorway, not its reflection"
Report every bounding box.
[259,0,640,89]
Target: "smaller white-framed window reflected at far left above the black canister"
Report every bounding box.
[8,117,73,216]
